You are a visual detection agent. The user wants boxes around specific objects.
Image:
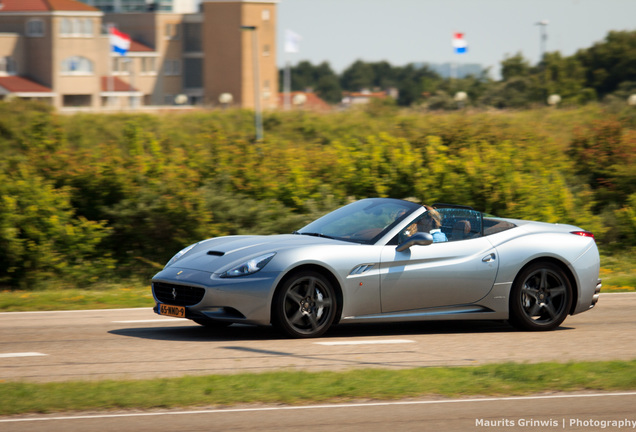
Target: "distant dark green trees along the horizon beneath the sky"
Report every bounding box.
[280,31,636,110]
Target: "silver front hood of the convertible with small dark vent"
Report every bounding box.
[166,234,355,273]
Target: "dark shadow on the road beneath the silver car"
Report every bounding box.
[109,321,571,342]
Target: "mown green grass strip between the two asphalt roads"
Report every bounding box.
[0,360,636,415]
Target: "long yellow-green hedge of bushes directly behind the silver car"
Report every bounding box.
[0,101,636,289]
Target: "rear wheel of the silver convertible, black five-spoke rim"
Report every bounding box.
[510,262,572,331]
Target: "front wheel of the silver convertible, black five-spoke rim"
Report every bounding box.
[272,271,338,338]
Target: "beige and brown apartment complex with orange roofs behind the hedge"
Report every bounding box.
[0,0,278,110]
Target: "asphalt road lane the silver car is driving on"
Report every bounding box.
[0,293,636,382]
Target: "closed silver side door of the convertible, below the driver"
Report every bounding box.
[380,237,499,313]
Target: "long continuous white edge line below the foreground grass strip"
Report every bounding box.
[0,392,636,423]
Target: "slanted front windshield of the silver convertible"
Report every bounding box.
[296,198,421,244]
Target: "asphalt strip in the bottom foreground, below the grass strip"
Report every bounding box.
[0,392,636,432]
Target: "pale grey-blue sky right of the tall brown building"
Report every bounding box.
[277,0,636,77]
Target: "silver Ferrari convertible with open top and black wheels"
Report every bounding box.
[152,198,601,337]
